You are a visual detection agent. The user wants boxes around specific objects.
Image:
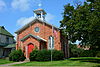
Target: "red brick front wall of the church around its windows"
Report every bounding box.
[17,21,61,50]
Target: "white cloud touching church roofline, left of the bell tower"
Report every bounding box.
[17,16,34,26]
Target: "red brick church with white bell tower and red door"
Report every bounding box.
[15,9,68,58]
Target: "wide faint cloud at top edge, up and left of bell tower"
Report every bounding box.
[11,0,42,11]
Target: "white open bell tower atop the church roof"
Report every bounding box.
[33,9,46,21]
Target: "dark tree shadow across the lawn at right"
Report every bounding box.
[70,57,100,63]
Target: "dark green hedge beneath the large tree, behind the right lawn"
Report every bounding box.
[70,44,99,57]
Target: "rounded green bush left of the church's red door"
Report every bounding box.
[9,50,25,61]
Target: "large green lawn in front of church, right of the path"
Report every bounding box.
[14,57,100,67]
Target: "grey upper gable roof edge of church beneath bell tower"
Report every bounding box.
[15,18,59,33]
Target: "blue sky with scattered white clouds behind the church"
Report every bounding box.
[0,0,84,43]
